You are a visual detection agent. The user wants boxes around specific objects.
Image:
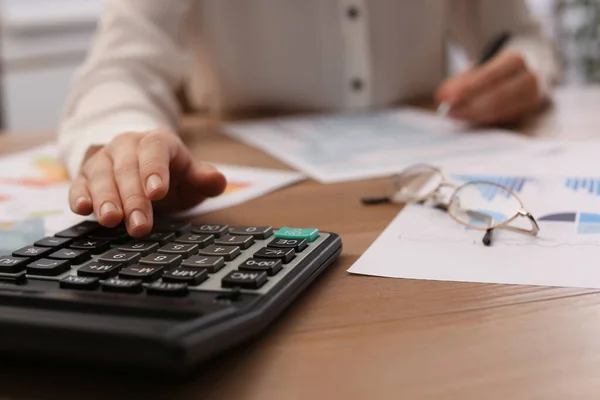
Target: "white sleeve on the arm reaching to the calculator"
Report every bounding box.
[58,0,192,177]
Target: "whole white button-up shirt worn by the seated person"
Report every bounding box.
[59,0,556,176]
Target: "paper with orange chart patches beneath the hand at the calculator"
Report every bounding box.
[0,145,304,253]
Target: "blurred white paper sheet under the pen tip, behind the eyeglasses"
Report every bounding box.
[225,108,552,183]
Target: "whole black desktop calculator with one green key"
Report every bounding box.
[0,220,342,374]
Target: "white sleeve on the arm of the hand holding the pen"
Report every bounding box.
[448,0,559,95]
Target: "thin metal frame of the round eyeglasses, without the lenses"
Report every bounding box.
[361,164,540,246]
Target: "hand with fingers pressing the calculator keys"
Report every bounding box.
[69,131,226,237]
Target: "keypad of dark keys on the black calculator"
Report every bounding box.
[0,222,327,297]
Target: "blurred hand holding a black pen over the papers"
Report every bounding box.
[436,34,542,125]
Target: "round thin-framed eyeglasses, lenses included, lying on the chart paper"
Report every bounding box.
[362,164,540,246]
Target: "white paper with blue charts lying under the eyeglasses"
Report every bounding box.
[348,175,600,288]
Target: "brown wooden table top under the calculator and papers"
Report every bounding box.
[0,88,600,400]
